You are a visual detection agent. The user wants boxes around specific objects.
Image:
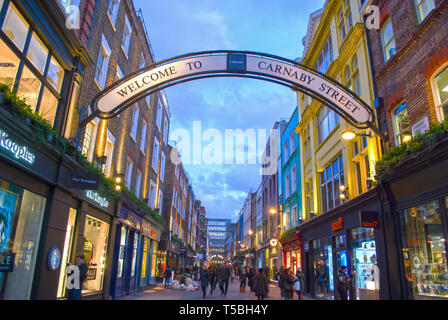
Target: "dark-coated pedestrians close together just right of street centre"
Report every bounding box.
[236,266,269,300]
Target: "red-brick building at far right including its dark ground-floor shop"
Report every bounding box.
[367,0,448,300]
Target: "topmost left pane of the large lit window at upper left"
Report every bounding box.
[2,4,29,51]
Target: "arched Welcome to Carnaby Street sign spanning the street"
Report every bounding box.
[86,50,378,132]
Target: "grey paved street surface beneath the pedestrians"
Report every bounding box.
[123,280,309,300]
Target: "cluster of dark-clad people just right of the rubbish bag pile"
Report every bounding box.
[199,264,233,298]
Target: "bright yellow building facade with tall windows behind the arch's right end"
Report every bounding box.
[296,0,381,222]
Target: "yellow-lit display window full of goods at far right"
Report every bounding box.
[400,200,448,299]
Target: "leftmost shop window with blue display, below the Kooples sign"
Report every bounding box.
[0,180,46,300]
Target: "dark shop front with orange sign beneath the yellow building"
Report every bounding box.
[300,190,388,300]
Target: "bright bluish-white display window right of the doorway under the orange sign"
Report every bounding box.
[351,228,380,300]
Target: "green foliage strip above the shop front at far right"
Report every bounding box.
[375,119,448,180]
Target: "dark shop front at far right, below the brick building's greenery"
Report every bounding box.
[381,139,448,300]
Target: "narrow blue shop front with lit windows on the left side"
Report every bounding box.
[111,204,143,298]
